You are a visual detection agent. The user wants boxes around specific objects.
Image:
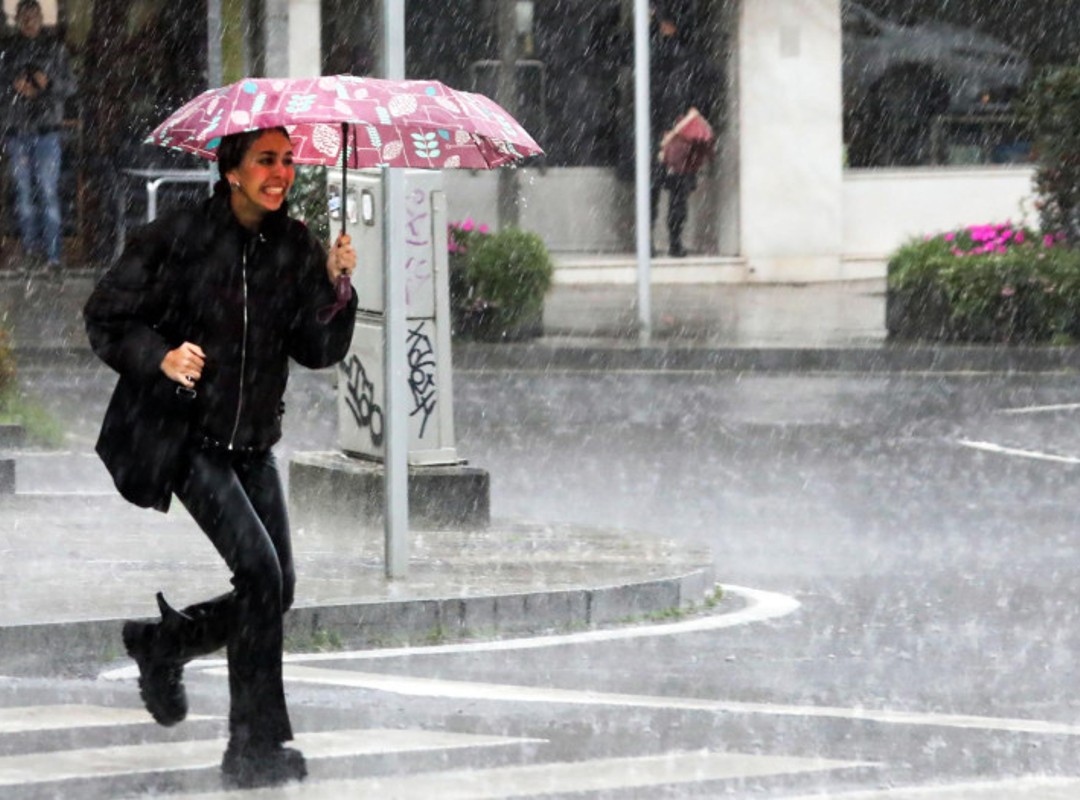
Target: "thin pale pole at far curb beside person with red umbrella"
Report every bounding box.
[634,0,653,344]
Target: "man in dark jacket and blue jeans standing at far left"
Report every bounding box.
[0,0,76,271]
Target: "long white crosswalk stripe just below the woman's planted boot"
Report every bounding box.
[162,751,873,800]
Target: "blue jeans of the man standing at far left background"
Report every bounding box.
[4,131,60,266]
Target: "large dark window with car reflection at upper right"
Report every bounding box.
[842,0,1080,167]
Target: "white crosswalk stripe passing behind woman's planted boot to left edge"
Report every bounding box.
[0,729,531,785]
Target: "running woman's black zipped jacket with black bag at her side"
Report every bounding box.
[84,192,356,511]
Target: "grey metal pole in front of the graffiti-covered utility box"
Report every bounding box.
[382,0,409,578]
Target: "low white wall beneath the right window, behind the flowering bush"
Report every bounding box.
[843,166,1037,259]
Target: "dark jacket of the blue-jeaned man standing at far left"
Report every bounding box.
[0,31,76,135]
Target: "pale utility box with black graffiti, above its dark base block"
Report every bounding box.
[327,170,461,465]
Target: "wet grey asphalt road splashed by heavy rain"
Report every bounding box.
[6,358,1080,798]
